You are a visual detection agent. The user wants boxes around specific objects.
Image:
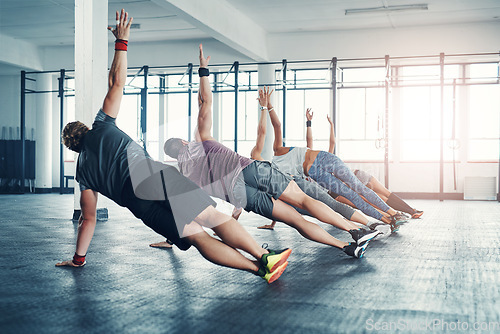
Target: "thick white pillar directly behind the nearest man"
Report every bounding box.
[73,0,108,219]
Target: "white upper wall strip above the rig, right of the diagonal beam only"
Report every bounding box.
[268,22,500,60]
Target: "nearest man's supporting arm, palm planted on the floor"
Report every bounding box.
[56,189,97,267]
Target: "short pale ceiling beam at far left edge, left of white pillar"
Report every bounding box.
[0,33,43,71]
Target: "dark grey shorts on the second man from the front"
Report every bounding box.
[234,161,292,219]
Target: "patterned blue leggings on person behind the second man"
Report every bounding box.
[309,151,389,220]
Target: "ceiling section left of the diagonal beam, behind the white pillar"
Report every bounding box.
[0,0,209,46]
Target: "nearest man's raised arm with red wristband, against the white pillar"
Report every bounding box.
[102,9,133,118]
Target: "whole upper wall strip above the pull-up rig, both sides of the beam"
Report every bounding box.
[42,22,500,70]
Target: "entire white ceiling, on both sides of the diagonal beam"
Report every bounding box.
[0,0,500,47]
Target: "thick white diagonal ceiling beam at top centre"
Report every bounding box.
[151,0,268,61]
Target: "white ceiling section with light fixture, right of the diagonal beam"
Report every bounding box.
[228,0,500,33]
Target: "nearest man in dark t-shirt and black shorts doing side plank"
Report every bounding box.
[56,9,291,283]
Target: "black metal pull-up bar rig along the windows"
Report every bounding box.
[21,52,500,202]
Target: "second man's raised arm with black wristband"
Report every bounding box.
[195,44,214,141]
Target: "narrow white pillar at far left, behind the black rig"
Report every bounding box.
[35,74,52,192]
